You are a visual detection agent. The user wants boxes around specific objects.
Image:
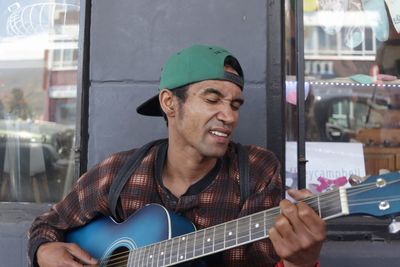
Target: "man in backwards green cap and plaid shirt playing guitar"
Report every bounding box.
[29,45,325,267]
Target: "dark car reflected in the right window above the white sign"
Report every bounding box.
[308,79,392,142]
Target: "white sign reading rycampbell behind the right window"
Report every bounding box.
[286,142,365,193]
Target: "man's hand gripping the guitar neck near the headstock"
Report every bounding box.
[269,189,326,267]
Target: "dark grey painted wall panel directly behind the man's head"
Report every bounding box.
[88,0,273,167]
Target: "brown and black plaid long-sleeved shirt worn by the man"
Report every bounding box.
[28,143,282,266]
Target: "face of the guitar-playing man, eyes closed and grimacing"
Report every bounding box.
[169,70,243,160]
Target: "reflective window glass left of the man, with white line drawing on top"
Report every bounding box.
[0,0,80,202]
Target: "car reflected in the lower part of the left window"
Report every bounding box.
[0,119,74,202]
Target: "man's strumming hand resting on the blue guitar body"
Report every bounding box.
[36,242,97,267]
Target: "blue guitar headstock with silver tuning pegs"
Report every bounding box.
[346,172,400,220]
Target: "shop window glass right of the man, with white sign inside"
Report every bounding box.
[286,0,400,193]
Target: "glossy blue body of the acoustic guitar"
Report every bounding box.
[66,204,196,261]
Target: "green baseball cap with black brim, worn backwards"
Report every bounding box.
[136,45,243,116]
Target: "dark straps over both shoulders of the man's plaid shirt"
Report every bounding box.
[108,139,250,219]
